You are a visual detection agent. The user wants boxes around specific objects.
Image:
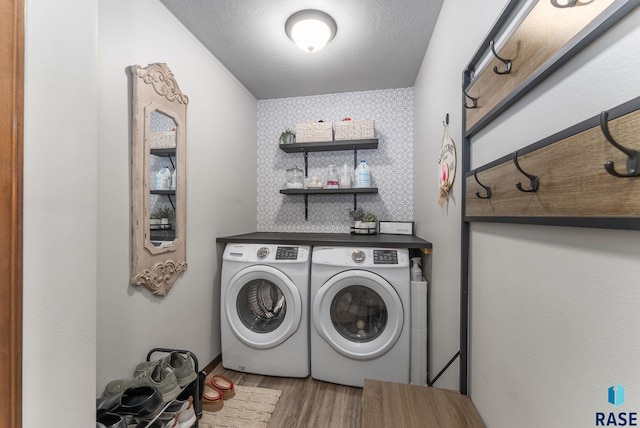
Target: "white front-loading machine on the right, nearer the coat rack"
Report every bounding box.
[310,247,411,387]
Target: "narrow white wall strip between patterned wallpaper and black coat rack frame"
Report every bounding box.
[413,0,504,389]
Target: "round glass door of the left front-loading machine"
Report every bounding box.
[223,265,302,349]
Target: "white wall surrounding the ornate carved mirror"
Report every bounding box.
[96,0,257,394]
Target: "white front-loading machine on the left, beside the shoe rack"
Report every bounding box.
[220,244,310,377]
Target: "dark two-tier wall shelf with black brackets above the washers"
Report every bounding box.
[280,138,378,220]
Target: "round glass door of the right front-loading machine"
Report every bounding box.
[313,270,404,360]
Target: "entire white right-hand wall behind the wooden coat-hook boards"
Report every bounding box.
[414,0,640,427]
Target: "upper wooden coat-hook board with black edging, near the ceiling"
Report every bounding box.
[462,0,639,136]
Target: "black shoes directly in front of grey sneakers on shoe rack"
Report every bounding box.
[96,386,164,420]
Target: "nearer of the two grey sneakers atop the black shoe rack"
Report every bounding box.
[102,362,180,403]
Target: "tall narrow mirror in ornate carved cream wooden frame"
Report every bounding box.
[131,64,189,296]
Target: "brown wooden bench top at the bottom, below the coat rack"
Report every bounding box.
[362,379,485,428]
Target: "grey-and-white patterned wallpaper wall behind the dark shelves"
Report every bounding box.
[258,88,414,233]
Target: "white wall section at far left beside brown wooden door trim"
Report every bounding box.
[22,0,98,428]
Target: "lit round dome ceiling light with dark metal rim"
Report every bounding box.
[284,9,338,52]
